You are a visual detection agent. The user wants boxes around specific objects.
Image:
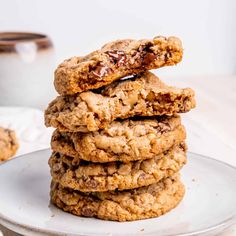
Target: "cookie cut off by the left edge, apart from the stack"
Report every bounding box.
[0,127,19,162]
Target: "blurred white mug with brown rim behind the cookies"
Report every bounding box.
[0,32,55,108]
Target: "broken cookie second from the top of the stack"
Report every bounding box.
[45,72,195,132]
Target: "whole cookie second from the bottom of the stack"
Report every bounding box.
[49,143,187,192]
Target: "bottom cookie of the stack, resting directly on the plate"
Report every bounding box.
[51,175,185,221]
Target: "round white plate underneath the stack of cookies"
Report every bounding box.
[0,150,236,236]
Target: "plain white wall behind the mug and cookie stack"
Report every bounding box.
[0,0,236,76]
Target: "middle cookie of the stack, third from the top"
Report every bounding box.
[51,115,186,162]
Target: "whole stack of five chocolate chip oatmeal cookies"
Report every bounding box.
[45,36,195,221]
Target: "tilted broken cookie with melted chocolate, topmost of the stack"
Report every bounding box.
[54,36,183,95]
